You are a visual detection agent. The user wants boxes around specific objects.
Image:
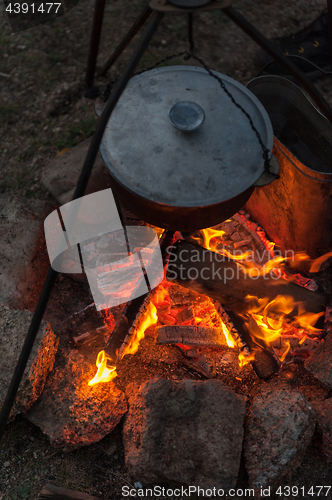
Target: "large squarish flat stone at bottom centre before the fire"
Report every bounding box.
[123,379,245,489]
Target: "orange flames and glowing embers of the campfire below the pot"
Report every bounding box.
[89,211,330,386]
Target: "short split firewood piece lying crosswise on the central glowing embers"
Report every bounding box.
[157,325,228,349]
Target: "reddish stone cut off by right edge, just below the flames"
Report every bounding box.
[304,333,332,389]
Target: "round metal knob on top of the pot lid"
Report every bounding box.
[168,101,205,132]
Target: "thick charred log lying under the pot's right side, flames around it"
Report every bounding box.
[167,241,326,326]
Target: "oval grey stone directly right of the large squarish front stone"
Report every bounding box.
[244,383,315,489]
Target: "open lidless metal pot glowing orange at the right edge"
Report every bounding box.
[246,76,332,259]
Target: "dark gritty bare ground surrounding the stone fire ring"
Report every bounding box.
[0,0,332,500]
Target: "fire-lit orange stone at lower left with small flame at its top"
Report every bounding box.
[26,349,128,452]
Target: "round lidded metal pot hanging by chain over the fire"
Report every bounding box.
[100,66,274,231]
